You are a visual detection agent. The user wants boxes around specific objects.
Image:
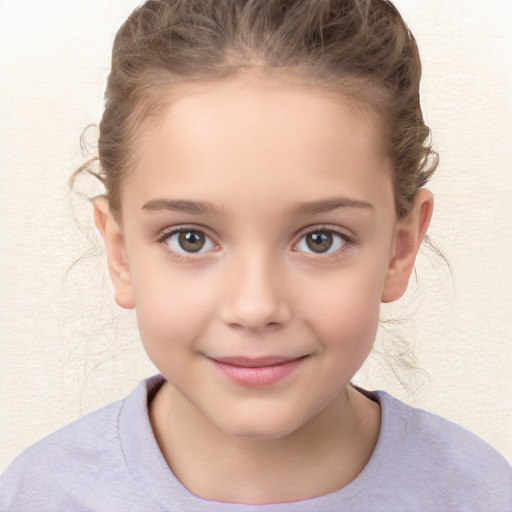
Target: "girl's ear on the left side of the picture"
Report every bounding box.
[93,196,135,309]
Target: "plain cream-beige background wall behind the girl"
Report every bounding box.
[0,0,512,469]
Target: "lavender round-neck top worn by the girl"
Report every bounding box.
[0,376,512,512]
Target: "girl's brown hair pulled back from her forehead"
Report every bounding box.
[86,0,438,217]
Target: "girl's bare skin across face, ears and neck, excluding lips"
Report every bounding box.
[95,77,433,504]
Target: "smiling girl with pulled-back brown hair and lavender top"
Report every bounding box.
[1,0,512,511]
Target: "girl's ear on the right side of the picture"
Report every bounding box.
[381,188,434,302]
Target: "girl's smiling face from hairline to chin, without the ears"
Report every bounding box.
[100,79,424,438]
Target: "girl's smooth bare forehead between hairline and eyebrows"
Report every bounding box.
[122,77,392,217]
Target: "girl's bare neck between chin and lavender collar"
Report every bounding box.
[150,384,380,504]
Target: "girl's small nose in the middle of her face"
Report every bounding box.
[221,251,291,332]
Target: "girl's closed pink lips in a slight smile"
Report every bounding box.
[209,356,308,388]
